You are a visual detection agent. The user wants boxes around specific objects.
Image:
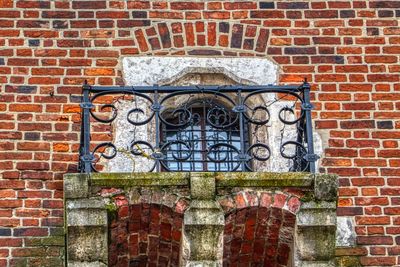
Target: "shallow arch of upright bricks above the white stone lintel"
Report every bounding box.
[134,20,269,55]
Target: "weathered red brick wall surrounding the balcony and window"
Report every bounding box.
[0,0,400,266]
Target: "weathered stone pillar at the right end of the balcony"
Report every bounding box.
[295,175,337,267]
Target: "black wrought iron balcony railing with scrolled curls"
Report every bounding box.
[79,81,318,173]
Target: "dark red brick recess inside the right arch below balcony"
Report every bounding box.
[224,207,296,266]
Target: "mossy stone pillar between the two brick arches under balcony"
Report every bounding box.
[184,173,225,267]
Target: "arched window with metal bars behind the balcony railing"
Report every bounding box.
[160,96,248,171]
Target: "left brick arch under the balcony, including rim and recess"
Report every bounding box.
[104,190,188,267]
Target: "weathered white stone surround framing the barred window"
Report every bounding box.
[103,56,322,172]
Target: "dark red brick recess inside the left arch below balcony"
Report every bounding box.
[109,203,183,267]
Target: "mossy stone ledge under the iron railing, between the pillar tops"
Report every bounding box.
[78,172,315,188]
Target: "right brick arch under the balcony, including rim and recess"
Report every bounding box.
[219,191,301,266]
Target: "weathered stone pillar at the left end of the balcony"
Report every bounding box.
[64,175,108,267]
